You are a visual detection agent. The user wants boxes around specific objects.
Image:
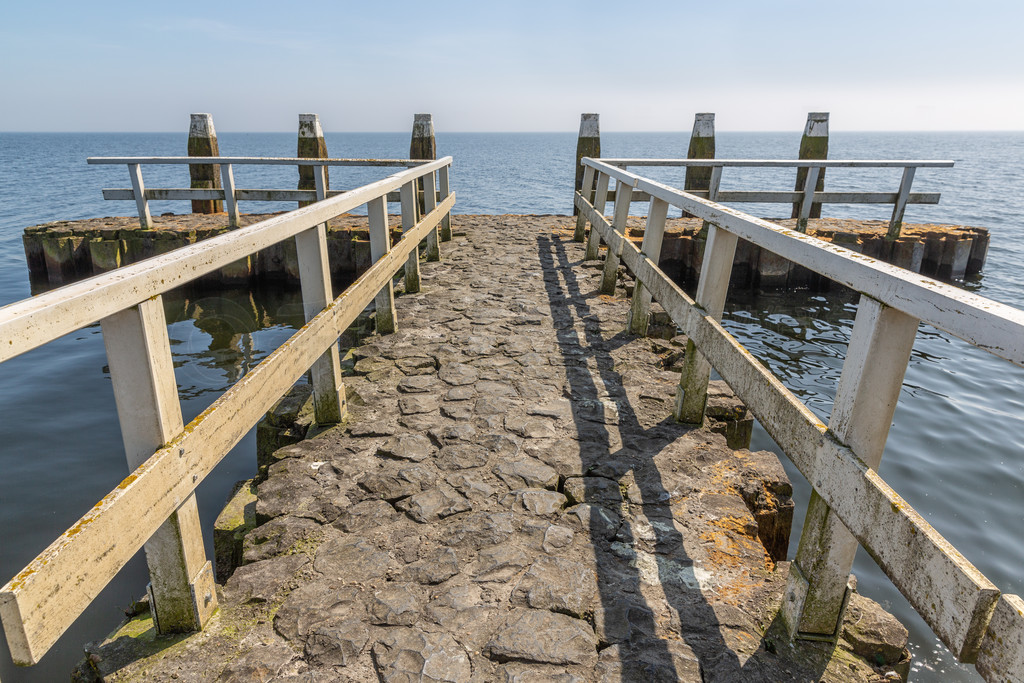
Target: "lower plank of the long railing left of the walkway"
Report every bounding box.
[0,189,456,665]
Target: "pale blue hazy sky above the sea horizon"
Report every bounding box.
[0,0,1024,132]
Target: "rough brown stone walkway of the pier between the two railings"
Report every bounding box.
[79,216,908,682]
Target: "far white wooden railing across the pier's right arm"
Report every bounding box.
[577,159,953,240]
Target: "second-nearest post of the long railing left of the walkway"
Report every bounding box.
[295,174,347,425]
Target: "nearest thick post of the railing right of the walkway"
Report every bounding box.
[782,296,919,640]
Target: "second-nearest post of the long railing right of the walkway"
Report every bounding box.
[675,224,736,424]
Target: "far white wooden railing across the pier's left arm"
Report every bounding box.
[86,157,451,238]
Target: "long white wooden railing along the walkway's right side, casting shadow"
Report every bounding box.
[574,159,1024,681]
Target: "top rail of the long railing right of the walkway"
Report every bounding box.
[585,160,1024,366]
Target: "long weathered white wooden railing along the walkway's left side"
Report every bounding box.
[0,157,455,666]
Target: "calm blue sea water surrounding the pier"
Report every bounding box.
[0,132,1024,682]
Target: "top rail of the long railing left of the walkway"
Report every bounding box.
[0,157,454,362]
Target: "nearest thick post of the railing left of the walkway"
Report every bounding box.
[100,296,217,633]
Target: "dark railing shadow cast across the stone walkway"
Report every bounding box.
[538,236,828,681]
